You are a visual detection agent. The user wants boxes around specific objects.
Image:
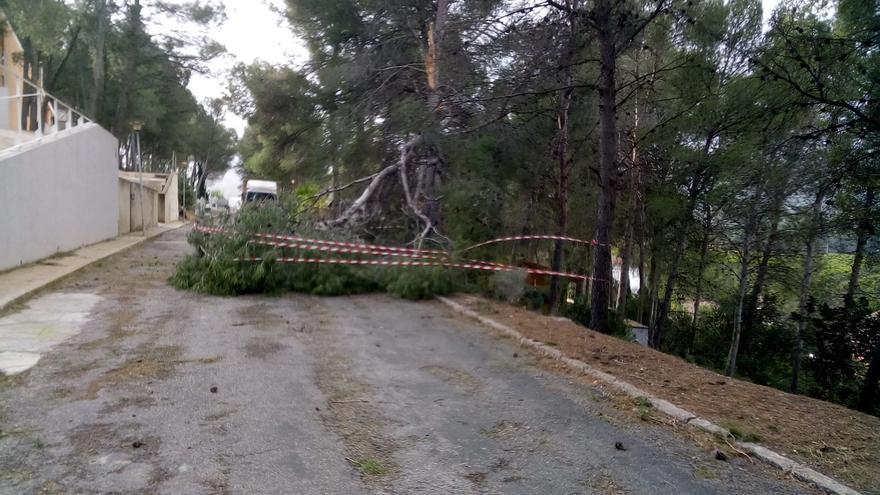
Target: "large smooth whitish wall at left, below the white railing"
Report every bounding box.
[0,124,119,270]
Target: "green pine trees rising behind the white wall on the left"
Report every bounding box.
[0,0,237,196]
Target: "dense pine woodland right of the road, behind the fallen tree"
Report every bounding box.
[231,0,880,416]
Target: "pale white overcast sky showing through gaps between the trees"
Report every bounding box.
[180,0,780,205]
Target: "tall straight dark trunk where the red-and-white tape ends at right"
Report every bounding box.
[590,0,617,333]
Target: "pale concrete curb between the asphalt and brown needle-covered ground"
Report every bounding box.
[437,296,861,495]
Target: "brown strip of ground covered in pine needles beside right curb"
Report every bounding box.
[455,296,880,493]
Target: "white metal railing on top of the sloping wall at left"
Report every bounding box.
[0,64,92,142]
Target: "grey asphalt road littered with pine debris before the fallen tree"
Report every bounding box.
[0,230,807,494]
